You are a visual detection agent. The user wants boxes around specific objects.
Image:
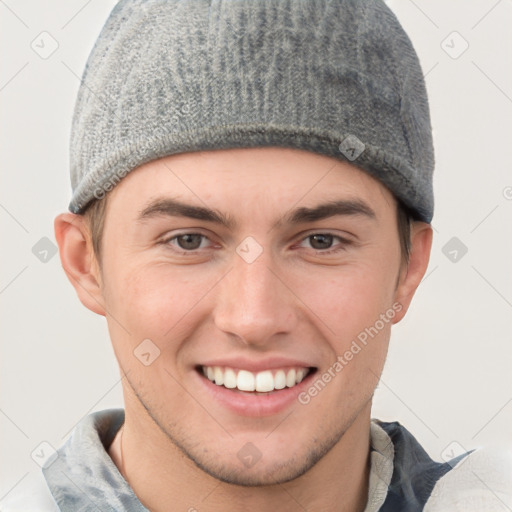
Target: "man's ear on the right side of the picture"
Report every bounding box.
[393,221,432,324]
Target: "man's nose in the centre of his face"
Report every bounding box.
[214,245,298,346]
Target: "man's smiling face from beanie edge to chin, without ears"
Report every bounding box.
[96,148,408,485]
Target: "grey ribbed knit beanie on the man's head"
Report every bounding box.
[69,0,434,222]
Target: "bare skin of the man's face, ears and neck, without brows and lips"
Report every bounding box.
[55,148,432,511]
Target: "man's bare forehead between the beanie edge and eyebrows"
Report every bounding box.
[109,147,395,218]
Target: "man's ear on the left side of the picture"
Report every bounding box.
[54,213,105,316]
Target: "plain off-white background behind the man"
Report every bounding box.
[0,0,512,503]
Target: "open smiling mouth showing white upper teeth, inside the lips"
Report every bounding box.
[197,366,316,394]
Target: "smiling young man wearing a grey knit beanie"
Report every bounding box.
[5,0,511,512]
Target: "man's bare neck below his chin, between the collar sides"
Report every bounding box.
[109,394,370,512]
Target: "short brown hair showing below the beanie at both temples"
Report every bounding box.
[83,194,413,265]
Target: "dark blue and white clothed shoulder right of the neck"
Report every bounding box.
[371,420,512,512]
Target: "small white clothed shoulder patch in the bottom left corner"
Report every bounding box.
[0,471,60,512]
